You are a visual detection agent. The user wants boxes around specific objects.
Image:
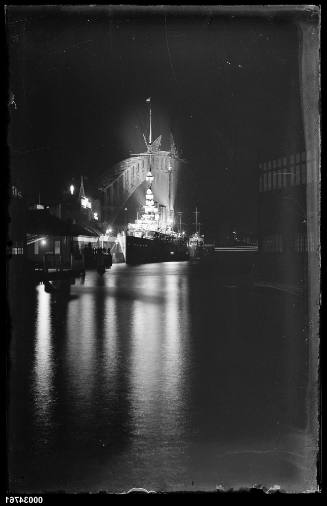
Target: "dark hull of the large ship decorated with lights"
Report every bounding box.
[125,236,189,264]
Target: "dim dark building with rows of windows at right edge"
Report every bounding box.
[257,151,319,284]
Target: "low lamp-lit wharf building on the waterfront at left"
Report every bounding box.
[7,185,101,280]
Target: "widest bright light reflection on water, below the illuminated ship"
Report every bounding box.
[120,263,189,489]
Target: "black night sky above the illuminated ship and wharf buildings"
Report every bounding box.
[7,6,303,239]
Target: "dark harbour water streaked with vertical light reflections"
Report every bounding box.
[8,262,311,492]
